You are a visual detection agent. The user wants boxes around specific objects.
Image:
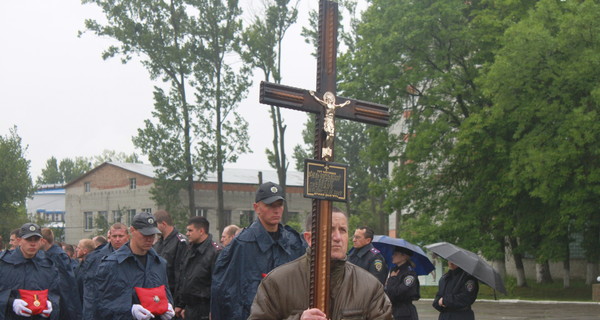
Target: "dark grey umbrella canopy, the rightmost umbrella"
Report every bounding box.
[425,242,506,294]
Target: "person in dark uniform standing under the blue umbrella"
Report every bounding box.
[385,247,421,320]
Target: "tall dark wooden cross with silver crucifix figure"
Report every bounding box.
[260,0,389,314]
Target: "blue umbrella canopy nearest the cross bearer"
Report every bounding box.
[371,236,435,276]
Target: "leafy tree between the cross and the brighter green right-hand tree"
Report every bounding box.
[344,0,532,280]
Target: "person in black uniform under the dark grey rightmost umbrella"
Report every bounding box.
[433,261,479,320]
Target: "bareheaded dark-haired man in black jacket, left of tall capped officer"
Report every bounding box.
[175,217,221,320]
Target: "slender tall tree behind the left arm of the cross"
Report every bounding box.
[242,0,298,223]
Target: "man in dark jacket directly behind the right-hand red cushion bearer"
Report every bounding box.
[154,210,188,296]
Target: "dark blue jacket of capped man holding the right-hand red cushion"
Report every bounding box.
[94,243,173,320]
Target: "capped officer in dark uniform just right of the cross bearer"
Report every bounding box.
[348,226,388,284]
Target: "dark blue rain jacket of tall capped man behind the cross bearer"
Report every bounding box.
[211,220,306,320]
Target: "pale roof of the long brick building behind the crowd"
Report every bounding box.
[69,162,304,186]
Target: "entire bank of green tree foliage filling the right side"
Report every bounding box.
[343,0,600,286]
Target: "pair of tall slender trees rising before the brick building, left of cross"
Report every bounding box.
[84,0,250,228]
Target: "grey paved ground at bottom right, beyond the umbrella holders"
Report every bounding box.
[415,299,600,320]
